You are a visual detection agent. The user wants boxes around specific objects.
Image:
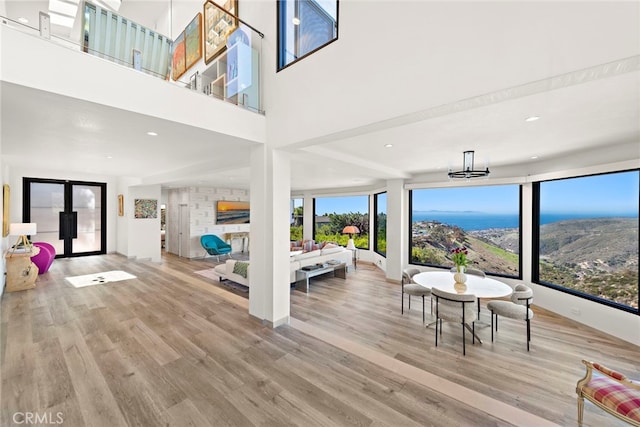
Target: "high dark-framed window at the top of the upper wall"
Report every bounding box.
[278,0,338,71]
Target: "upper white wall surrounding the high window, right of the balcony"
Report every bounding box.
[262,0,639,146]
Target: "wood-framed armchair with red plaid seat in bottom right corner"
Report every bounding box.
[576,360,640,427]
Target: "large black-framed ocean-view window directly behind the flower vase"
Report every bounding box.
[409,185,521,277]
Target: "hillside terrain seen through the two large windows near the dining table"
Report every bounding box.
[411,218,638,307]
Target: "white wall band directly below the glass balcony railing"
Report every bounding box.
[0,25,265,142]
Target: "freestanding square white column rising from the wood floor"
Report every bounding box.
[249,145,292,327]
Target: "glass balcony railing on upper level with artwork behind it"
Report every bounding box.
[1,0,264,114]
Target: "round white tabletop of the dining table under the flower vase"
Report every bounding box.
[413,271,513,298]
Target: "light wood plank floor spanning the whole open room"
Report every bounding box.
[0,255,640,426]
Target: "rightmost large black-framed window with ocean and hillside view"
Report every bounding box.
[533,170,640,313]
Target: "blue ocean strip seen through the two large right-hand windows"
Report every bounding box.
[413,212,628,231]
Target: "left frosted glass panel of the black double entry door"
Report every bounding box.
[30,182,64,254]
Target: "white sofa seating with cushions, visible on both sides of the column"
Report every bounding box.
[214,247,353,286]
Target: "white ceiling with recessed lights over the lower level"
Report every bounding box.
[1,0,640,191]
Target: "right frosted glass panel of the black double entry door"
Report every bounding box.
[72,184,102,254]
